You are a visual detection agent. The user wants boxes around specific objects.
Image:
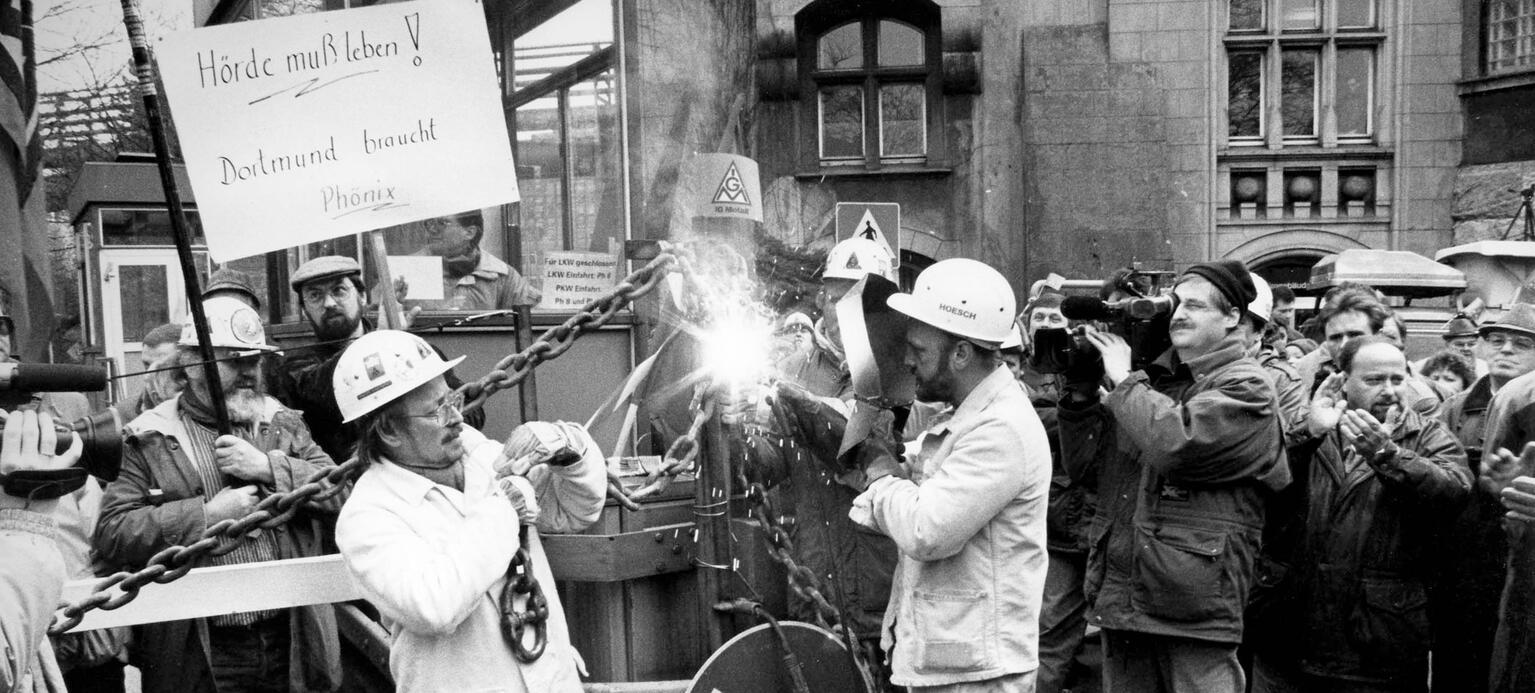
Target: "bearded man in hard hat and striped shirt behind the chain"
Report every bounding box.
[94,297,342,693]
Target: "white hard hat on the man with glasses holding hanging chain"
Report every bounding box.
[330,330,464,423]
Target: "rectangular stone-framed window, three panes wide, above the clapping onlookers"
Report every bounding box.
[1225,0,1387,148]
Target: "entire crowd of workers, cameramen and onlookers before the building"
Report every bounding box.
[0,228,1535,693]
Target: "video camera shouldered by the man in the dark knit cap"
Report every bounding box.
[1028,267,1177,383]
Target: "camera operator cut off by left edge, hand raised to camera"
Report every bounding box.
[0,410,81,693]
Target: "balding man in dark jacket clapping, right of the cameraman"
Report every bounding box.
[1253,337,1471,693]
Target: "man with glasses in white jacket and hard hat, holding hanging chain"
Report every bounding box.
[335,330,606,693]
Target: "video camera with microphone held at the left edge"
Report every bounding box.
[0,363,123,499]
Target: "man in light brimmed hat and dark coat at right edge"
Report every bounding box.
[1431,303,1535,693]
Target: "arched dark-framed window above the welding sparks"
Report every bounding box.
[795,0,942,169]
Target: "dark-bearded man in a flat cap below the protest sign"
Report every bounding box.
[276,255,485,461]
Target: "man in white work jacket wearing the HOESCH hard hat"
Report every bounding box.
[850,258,1050,693]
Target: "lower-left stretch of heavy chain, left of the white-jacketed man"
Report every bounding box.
[48,459,365,635]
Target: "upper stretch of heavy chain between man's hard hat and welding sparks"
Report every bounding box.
[459,243,692,412]
